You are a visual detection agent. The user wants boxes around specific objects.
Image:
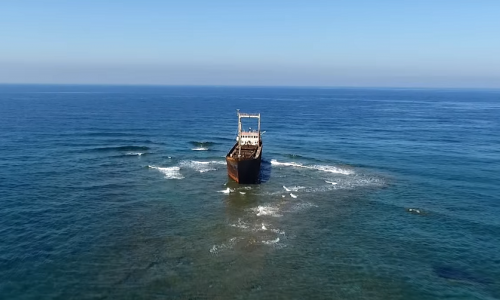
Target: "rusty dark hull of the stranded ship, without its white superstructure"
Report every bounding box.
[226,143,262,184]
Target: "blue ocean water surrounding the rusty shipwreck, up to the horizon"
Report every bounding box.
[0,85,500,299]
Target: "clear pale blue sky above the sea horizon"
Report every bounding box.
[0,0,500,88]
